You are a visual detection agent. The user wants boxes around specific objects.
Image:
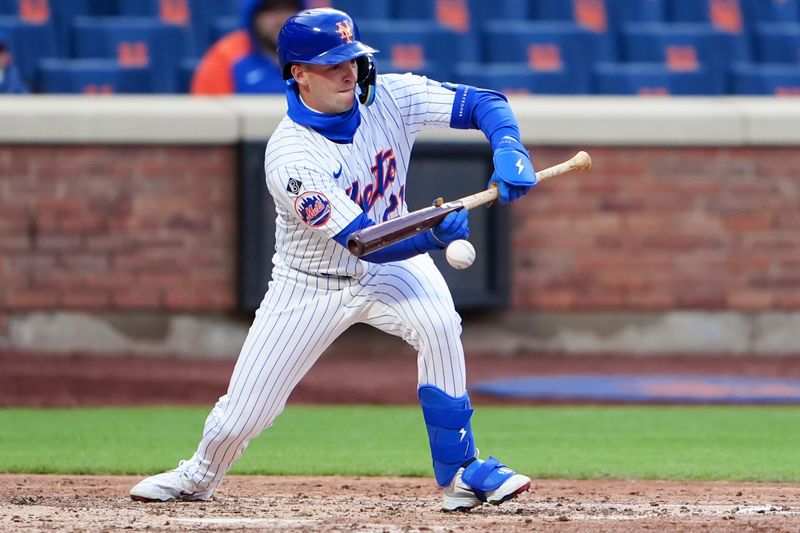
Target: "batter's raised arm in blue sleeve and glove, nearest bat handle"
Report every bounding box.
[442,84,536,204]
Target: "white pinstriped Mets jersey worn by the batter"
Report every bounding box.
[264,74,455,278]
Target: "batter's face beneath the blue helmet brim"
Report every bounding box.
[292,60,358,114]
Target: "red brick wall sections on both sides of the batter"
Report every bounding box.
[0,146,800,316]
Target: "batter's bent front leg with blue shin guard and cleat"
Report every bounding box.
[365,256,530,511]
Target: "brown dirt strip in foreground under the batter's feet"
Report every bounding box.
[0,475,800,532]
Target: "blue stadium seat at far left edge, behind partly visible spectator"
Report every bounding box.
[0,16,58,90]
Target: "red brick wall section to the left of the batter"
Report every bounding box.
[0,146,236,314]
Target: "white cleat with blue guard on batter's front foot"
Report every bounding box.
[443,458,531,512]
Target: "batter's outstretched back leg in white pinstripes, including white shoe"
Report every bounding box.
[131,274,354,501]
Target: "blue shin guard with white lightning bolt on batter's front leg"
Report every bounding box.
[418,385,475,487]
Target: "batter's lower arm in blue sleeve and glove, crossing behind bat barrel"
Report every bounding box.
[333,209,469,263]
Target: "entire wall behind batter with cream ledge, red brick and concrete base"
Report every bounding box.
[0,96,800,357]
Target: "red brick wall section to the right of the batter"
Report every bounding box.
[513,148,800,311]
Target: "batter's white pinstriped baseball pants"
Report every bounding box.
[188,255,466,490]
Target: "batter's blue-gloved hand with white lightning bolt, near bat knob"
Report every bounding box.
[489,137,536,204]
